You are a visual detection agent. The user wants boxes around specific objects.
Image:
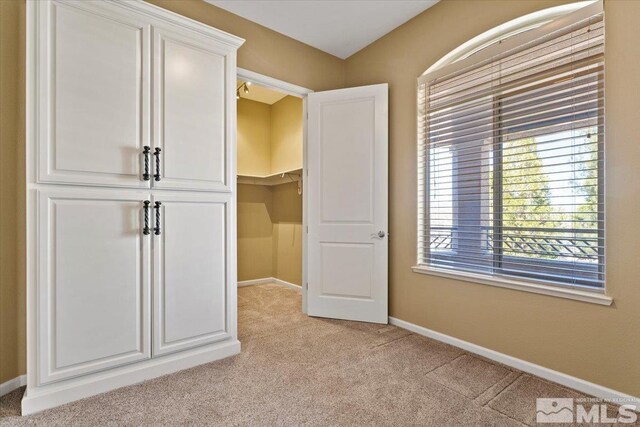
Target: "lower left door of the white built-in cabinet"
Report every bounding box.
[36,189,151,384]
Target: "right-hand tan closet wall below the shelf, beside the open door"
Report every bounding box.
[272,182,302,285]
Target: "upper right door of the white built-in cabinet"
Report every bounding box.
[153,27,235,191]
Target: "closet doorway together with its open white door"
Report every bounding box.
[237,69,389,323]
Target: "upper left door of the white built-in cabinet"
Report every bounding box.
[34,2,151,188]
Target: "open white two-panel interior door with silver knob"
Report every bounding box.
[306,84,388,323]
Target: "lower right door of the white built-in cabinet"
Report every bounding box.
[153,194,232,356]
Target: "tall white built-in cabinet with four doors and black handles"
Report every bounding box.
[23,0,242,414]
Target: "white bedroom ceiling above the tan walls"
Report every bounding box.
[205,0,438,59]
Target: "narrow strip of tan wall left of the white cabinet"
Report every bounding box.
[0,1,25,384]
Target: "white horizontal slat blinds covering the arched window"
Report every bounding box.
[418,4,605,290]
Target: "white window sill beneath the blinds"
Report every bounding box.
[411,265,613,305]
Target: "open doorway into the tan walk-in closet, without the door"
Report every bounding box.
[236,68,312,313]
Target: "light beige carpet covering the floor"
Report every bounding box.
[0,285,608,427]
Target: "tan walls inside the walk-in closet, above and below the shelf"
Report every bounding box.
[238,96,302,285]
